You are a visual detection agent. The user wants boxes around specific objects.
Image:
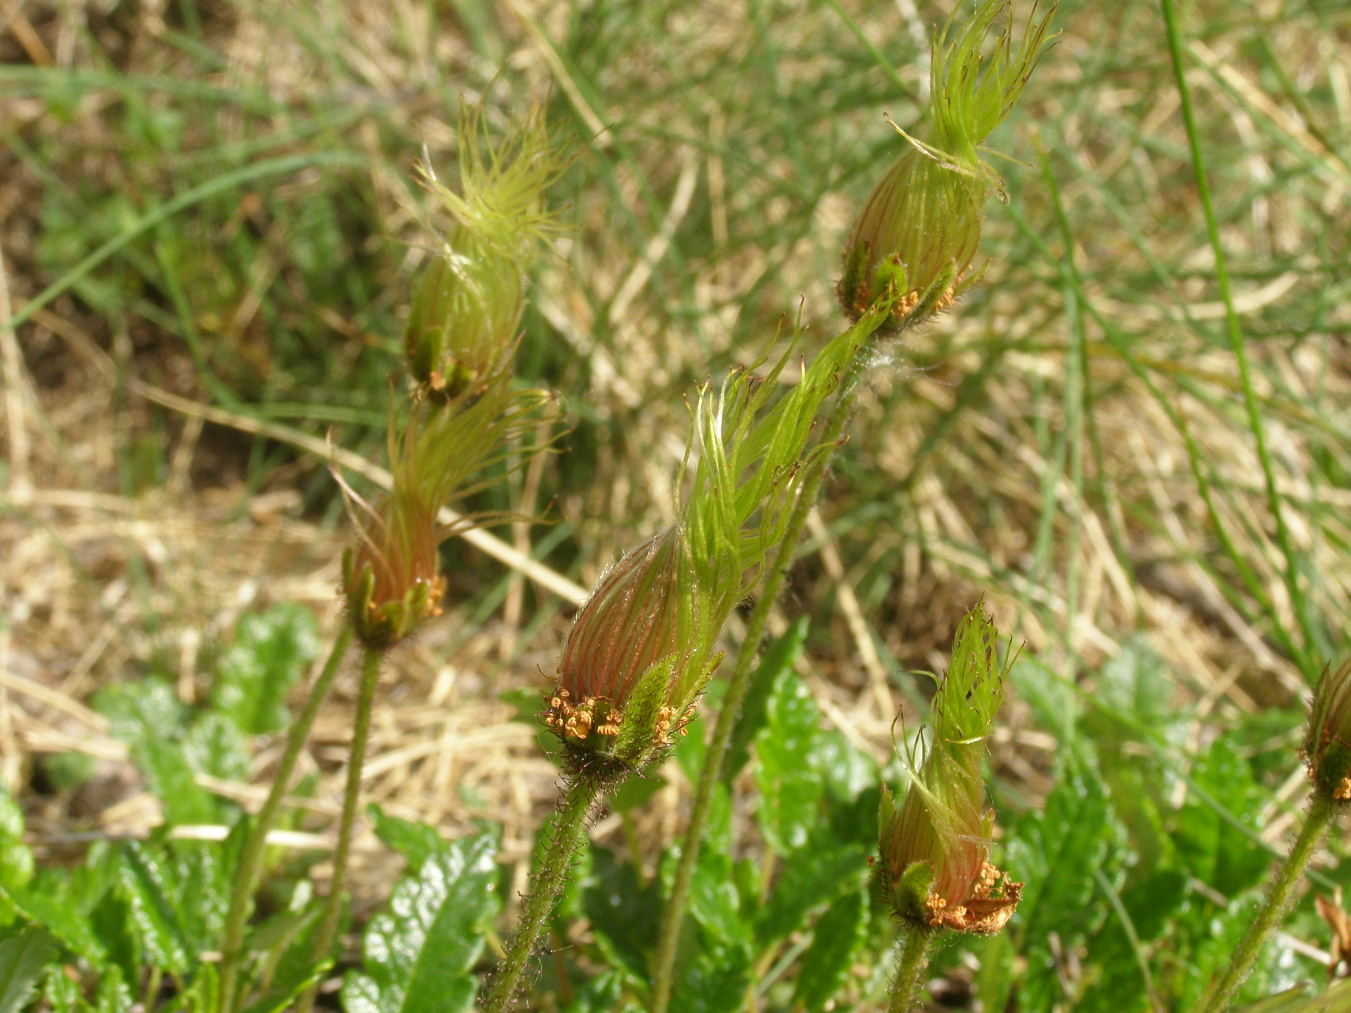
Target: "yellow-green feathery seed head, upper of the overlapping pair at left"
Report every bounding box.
[404,109,567,396]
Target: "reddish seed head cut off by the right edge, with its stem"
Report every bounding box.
[1204,658,1351,1013]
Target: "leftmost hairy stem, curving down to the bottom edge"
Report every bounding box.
[216,623,351,1013]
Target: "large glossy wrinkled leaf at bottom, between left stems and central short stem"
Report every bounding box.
[342,833,501,1013]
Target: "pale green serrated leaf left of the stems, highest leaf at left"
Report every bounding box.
[211,602,319,735]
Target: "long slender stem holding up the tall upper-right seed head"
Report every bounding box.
[653,343,867,1013]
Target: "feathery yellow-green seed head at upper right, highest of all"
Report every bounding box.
[838,0,1055,328]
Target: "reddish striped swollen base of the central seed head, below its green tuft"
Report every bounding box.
[544,527,712,767]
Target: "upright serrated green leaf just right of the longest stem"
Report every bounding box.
[755,671,821,855]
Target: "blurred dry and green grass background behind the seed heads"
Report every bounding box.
[0,0,1351,1010]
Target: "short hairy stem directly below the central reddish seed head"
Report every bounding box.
[482,777,601,1013]
